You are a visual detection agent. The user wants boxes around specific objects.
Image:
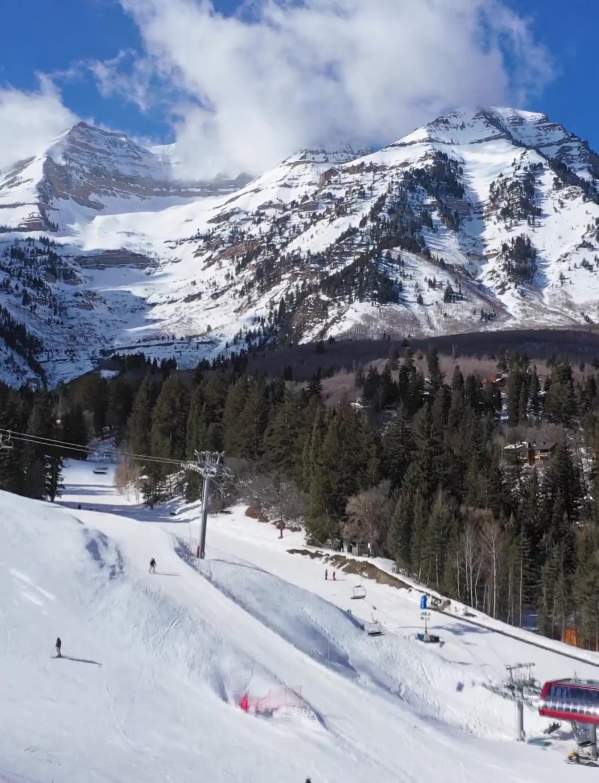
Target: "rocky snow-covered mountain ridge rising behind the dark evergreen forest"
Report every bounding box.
[0,108,599,382]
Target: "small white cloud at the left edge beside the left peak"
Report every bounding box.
[0,76,77,169]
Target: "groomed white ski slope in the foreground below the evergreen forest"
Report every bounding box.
[0,462,599,783]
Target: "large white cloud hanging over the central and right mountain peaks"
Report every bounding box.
[121,0,551,176]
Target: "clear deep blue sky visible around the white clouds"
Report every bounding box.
[0,0,599,172]
